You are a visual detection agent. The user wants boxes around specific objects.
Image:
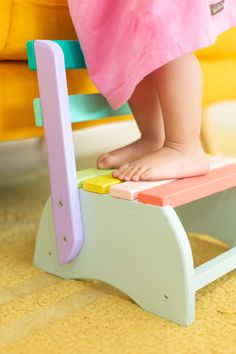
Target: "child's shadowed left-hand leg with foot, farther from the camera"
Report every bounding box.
[97,75,164,168]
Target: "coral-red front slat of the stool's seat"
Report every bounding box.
[138,163,236,207]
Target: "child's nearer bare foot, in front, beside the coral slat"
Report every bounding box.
[113,144,209,181]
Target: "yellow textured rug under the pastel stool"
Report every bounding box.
[0,171,236,354]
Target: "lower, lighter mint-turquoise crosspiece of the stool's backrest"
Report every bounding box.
[34,93,132,126]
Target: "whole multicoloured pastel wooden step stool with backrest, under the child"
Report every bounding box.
[27,40,236,325]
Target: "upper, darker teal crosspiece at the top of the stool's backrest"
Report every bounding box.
[27,40,86,70]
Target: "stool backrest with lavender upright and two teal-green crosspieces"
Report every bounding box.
[27,40,131,264]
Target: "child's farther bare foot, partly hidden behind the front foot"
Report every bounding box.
[97,138,163,169]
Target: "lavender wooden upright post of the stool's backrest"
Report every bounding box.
[35,40,83,264]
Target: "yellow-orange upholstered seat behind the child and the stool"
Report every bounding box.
[0,0,236,151]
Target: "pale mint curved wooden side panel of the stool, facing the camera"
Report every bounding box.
[34,189,195,325]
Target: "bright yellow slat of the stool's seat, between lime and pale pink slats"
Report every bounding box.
[83,173,121,194]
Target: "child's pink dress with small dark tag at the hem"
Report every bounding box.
[68,0,236,109]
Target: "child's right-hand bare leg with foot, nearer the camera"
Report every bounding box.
[113,54,208,181]
